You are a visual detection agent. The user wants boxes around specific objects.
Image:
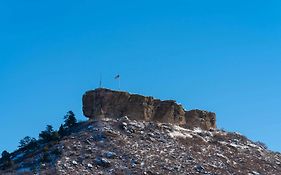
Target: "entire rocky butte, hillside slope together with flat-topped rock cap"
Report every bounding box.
[0,89,281,175]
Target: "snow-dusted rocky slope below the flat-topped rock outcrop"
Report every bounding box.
[0,117,281,175]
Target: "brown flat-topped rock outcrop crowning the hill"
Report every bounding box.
[83,88,216,130]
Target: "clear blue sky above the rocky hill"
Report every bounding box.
[0,0,281,151]
